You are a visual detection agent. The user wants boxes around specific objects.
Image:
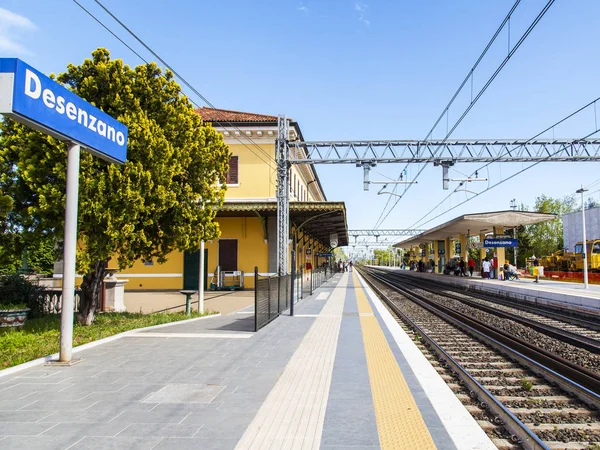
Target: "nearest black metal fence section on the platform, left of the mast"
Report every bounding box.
[254,267,291,331]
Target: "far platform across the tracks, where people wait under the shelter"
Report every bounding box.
[384,266,600,315]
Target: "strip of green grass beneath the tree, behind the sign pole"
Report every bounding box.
[0,312,212,369]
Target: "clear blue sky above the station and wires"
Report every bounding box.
[0,0,600,253]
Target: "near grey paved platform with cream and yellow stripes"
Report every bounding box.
[0,273,495,450]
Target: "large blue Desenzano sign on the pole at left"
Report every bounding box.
[0,58,127,163]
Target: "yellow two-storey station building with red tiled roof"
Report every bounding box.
[116,108,348,291]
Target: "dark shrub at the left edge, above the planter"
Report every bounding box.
[0,273,46,317]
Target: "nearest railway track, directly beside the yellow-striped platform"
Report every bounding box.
[361,269,600,450]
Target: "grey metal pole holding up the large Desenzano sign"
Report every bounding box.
[59,143,81,363]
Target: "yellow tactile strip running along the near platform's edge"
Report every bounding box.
[352,274,436,450]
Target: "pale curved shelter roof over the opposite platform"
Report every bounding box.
[394,210,556,248]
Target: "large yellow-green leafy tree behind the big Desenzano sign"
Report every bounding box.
[0,49,230,324]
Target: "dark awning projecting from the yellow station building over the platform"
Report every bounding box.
[217,200,348,247]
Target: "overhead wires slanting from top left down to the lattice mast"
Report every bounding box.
[73,0,275,171]
